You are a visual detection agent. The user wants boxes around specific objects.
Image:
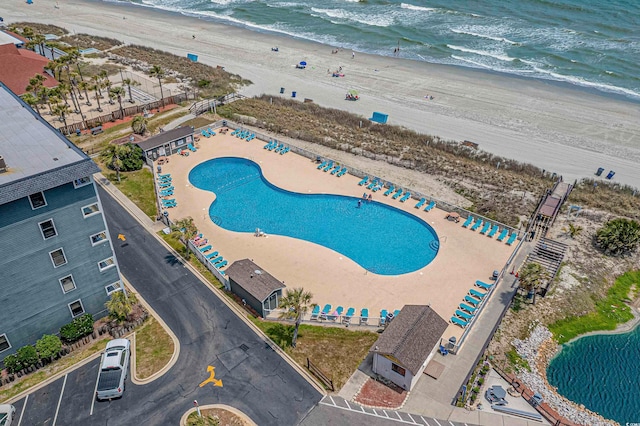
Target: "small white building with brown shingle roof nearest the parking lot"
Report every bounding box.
[370,305,448,390]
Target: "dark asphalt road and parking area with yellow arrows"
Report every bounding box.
[14,189,321,426]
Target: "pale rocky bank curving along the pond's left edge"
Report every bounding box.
[513,325,619,426]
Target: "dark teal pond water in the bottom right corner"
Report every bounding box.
[547,327,640,425]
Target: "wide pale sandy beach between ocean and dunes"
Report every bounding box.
[3,0,640,187]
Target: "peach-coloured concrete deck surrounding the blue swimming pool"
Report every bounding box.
[162,134,515,337]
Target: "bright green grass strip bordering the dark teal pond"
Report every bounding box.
[549,270,640,344]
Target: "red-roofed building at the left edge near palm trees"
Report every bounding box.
[0,43,58,95]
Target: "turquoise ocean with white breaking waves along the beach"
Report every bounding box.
[110,0,640,101]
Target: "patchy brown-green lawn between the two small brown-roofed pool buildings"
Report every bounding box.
[252,318,379,391]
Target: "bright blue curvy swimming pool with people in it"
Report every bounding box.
[189,157,439,275]
